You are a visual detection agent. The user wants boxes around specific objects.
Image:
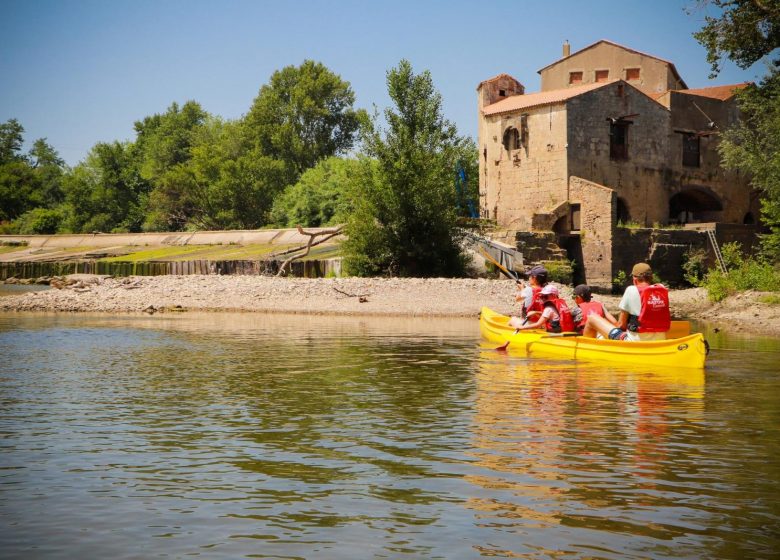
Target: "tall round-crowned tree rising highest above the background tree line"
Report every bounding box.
[244,60,363,186]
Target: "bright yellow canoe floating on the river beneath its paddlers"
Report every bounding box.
[479,307,707,368]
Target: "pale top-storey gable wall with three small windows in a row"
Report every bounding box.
[539,43,684,93]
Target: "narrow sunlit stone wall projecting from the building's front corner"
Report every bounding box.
[569,177,616,288]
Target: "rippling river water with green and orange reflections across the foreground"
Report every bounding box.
[0,314,780,558]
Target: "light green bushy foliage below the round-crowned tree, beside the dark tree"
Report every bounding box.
[271,157,362,227]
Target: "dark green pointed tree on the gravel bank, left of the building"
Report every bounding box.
[344,60,464,276]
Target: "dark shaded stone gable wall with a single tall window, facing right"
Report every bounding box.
[567,82,671,226]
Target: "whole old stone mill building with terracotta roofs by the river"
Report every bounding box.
[477,41,758,286]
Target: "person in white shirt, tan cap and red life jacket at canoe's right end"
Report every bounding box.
[583,263,671,341]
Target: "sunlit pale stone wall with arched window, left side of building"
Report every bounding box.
[479,104,568,229]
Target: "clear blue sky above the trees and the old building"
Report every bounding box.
[0,0,765,165]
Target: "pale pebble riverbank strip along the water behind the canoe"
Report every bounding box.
[0,275,780,336]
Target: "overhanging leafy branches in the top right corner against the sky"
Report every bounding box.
[693,0,780,78]
